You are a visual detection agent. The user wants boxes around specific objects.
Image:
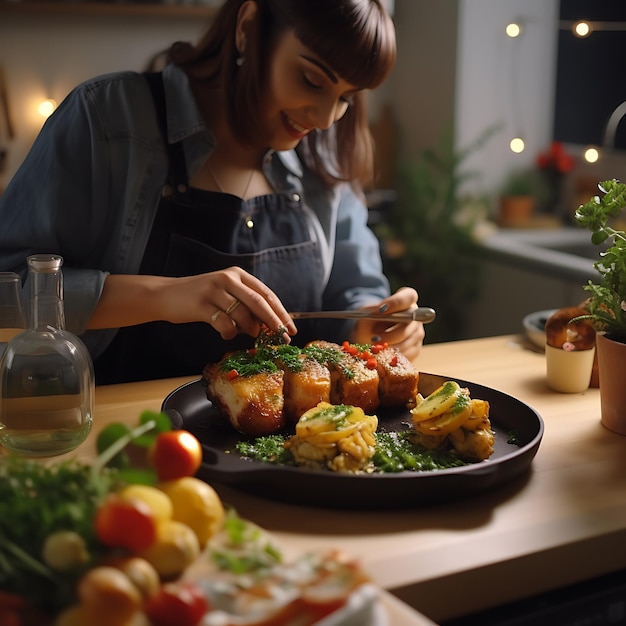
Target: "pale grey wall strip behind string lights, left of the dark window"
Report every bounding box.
[455,0,558,197]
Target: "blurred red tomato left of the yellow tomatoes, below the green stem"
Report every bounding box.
[94,494,157,552]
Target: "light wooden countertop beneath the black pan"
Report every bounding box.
[36,335,626,626]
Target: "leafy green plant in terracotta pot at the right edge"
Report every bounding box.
[574,179,626,435]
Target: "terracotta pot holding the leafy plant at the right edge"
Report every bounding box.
[596,333,626,435]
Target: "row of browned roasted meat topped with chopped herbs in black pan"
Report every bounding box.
[203,340,418,436]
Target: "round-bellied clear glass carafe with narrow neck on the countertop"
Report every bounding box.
[0,254,94,456]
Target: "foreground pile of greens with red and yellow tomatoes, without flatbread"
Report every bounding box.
[0,412,219,626]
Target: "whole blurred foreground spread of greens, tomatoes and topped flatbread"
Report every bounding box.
[0,412,366,626]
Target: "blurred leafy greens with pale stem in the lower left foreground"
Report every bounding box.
[0,411,171,612]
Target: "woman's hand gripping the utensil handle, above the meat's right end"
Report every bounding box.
[352,287,425,361]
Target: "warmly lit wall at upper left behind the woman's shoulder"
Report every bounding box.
[0,13,207,187]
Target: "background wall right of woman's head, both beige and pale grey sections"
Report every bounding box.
[390,0,558,201]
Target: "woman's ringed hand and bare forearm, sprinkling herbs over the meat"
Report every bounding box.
[89,267,297,342]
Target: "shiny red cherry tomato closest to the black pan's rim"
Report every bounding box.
[148,430,202,480]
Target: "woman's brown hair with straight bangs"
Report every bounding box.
[169,0,396,186]
